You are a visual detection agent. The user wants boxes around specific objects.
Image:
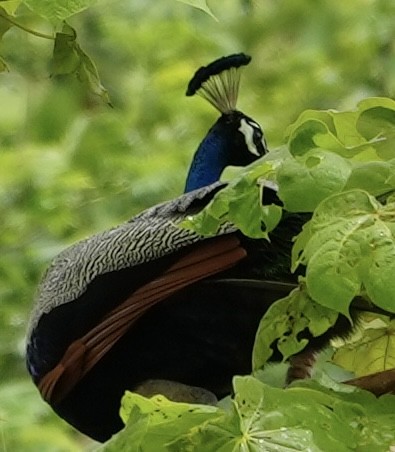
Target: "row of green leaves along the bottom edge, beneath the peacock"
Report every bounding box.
[104,377,395,452]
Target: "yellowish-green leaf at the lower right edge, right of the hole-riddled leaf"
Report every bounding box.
[333,314,395,377]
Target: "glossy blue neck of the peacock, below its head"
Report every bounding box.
[185,126,229,193]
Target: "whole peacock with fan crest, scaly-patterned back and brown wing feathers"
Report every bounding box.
[26,53,312,441]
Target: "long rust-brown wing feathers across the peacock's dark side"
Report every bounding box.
[38,235,246,403]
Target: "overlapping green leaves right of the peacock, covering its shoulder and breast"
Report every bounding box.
[185,98,395,368]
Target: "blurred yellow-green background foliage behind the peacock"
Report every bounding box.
[0,0,395,452]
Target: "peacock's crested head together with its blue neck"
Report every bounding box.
[185,54,266,192]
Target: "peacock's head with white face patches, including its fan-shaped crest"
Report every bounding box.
[186,53,267,166]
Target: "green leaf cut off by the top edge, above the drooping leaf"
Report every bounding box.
[23,0,97,23]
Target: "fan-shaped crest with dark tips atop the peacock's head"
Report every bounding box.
[186,53,251,113]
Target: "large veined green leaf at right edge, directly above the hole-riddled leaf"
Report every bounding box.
[300,190,395,315]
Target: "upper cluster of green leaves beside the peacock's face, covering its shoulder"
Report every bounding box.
[185,98,395,237]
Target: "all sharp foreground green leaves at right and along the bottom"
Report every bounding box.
[105,98,395,451]
